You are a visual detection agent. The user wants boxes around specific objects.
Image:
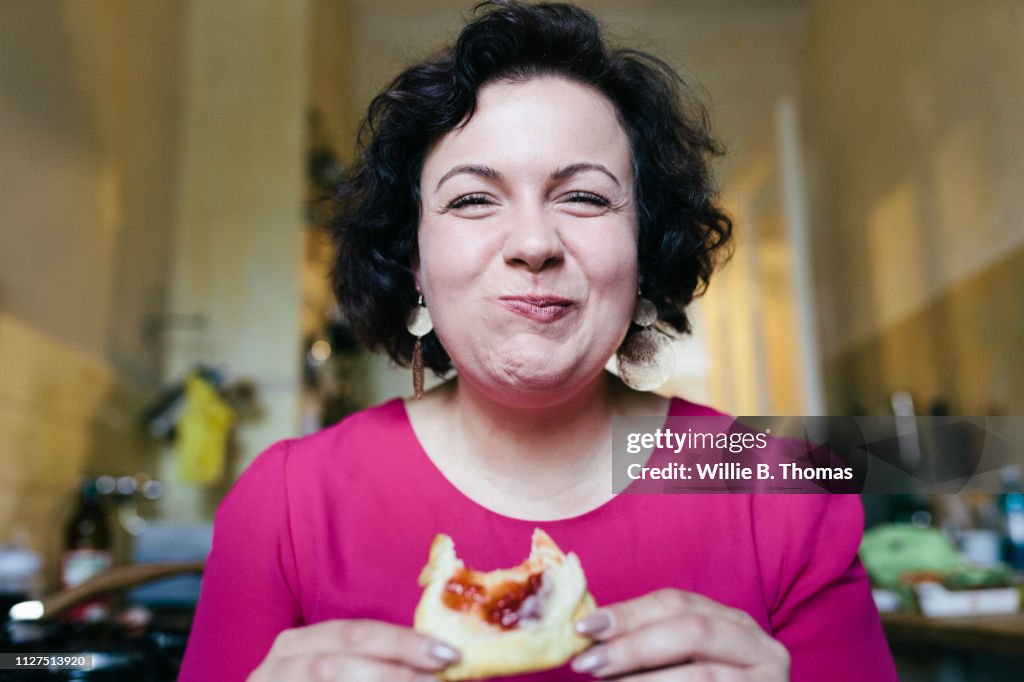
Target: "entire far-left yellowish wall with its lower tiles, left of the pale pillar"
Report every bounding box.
[0,0,181,581]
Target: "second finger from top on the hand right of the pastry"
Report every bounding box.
[572,612,775,677]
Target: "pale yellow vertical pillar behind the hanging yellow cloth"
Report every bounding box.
[159,0,309,520]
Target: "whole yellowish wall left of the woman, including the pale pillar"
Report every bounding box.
[0,0,309,586]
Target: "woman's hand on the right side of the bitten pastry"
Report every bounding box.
[572,590,790,682]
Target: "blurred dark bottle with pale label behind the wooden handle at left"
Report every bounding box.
[60,478,114,622]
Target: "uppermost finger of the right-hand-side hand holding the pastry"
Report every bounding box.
[575,590,760,641]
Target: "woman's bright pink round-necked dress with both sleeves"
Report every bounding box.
[179,398,897,682]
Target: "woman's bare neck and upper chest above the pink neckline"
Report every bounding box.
[407,374,667,519]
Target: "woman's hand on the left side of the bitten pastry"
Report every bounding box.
[247,621,460,682]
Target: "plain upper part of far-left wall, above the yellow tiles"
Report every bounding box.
[0,0,181,383]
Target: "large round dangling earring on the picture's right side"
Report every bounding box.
[615,292,676,391]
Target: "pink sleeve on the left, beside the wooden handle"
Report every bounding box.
[178,442,301,682]
